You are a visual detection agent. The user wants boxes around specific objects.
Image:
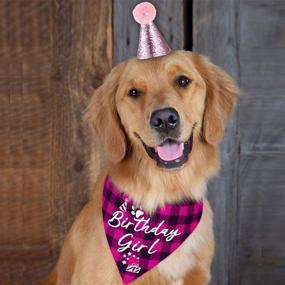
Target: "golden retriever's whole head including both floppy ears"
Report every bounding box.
[86,51,238,170]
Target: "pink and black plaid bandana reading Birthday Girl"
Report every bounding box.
[102,177,203,284]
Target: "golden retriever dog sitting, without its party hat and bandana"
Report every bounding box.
[41,51,239,285]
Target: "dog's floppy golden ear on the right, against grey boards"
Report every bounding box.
[195,56,239,145]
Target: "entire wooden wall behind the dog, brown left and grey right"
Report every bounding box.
[0,0,285,285]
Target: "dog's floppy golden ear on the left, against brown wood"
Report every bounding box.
[84,62,126,163]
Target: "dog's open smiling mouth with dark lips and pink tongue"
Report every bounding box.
[138,131,193,169]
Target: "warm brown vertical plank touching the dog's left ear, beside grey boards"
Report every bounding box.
[50,0,112,276]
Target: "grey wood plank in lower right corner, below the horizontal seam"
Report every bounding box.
[238,153,285,285]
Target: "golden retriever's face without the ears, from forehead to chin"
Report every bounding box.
[116,51,206,168]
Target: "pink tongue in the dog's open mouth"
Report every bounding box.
[155,141,183,161]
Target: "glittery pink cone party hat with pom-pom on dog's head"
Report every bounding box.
[133,2,171,59]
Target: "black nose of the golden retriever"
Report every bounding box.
[150,108,180,133]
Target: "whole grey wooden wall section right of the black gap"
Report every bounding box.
[193,0,285,285]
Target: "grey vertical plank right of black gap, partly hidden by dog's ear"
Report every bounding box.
[193,0,239,285]
